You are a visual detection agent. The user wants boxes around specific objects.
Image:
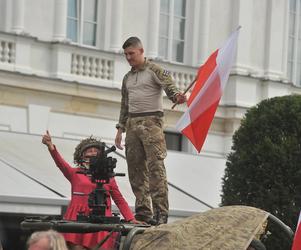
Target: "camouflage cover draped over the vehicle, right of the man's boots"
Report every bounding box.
[130,206,269,250]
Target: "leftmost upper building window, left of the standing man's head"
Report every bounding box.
[67,0,98,46]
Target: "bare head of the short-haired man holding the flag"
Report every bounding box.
[122,36,144,68]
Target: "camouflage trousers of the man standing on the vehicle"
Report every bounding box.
[125,116,169,220]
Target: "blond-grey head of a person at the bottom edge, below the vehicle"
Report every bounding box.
[27,230,67,250]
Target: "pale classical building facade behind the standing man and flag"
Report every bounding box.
[0,0,301,246]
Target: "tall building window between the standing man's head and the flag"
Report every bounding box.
[159,0,186,63]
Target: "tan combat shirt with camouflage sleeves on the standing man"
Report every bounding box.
[116,60,180,130]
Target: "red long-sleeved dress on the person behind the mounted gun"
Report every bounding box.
[50,148,134,249]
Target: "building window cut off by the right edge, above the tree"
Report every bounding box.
[287,0,301,86]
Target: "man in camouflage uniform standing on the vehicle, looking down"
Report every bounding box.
[115,37,186,225]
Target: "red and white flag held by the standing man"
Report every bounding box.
[176,28,239,152]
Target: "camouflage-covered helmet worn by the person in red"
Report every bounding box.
[73,135,103,166]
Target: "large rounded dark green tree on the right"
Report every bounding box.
[222,95,301,250]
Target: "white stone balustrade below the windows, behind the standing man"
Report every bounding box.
[0,32,197,90]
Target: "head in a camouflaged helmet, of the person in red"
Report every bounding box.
[73,136,103,166]
